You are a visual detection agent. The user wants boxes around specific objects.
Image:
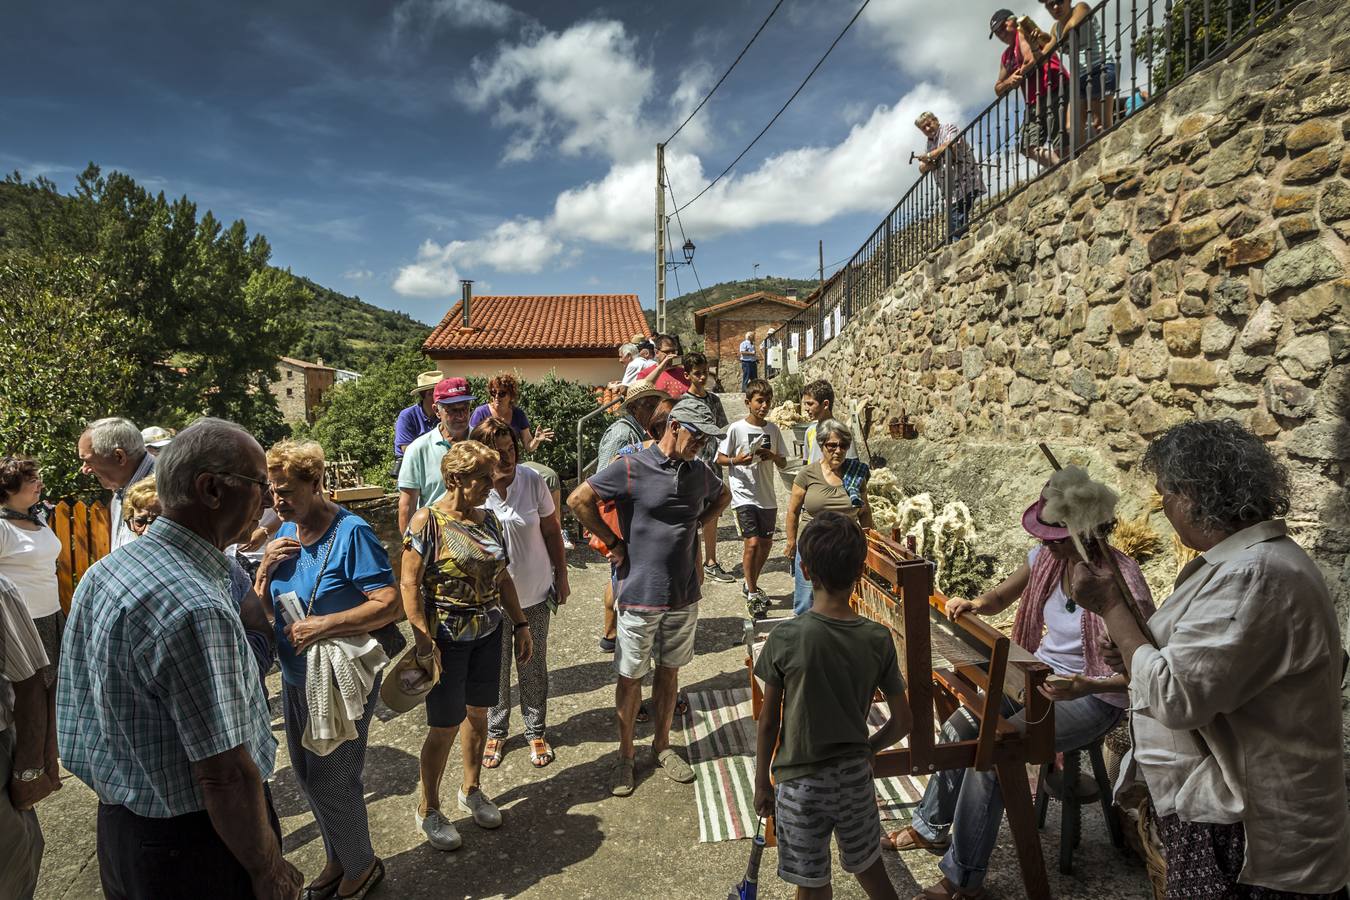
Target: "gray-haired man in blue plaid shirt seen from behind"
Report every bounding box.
[57,418,301,900]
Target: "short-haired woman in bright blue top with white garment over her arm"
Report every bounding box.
[257,441,401,900]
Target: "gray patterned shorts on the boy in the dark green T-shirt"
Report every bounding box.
[774,756,882,888]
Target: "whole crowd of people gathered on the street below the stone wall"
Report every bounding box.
[0,335,1350,900]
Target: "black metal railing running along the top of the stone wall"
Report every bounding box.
[778,0,1299,371]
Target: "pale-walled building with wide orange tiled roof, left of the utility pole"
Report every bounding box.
[423,294,648,385]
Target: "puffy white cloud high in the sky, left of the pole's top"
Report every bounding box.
[458,20,653,162]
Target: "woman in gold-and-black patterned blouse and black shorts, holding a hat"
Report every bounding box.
[400,441,533,850]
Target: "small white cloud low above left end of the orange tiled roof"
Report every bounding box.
[394,219,563,297]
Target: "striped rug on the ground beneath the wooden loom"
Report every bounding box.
[684,688,926,843]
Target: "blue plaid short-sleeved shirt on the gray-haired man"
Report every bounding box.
[57,517,277,818]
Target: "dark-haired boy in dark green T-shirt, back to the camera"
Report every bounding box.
[755,513,913,900]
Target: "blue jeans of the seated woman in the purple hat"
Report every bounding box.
[914,695,1125,888]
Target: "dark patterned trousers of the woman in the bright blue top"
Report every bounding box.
[282,677,379,877]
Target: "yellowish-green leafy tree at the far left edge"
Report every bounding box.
[0,258,144,497]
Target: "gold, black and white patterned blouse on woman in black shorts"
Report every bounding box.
[404,506,510,641]
